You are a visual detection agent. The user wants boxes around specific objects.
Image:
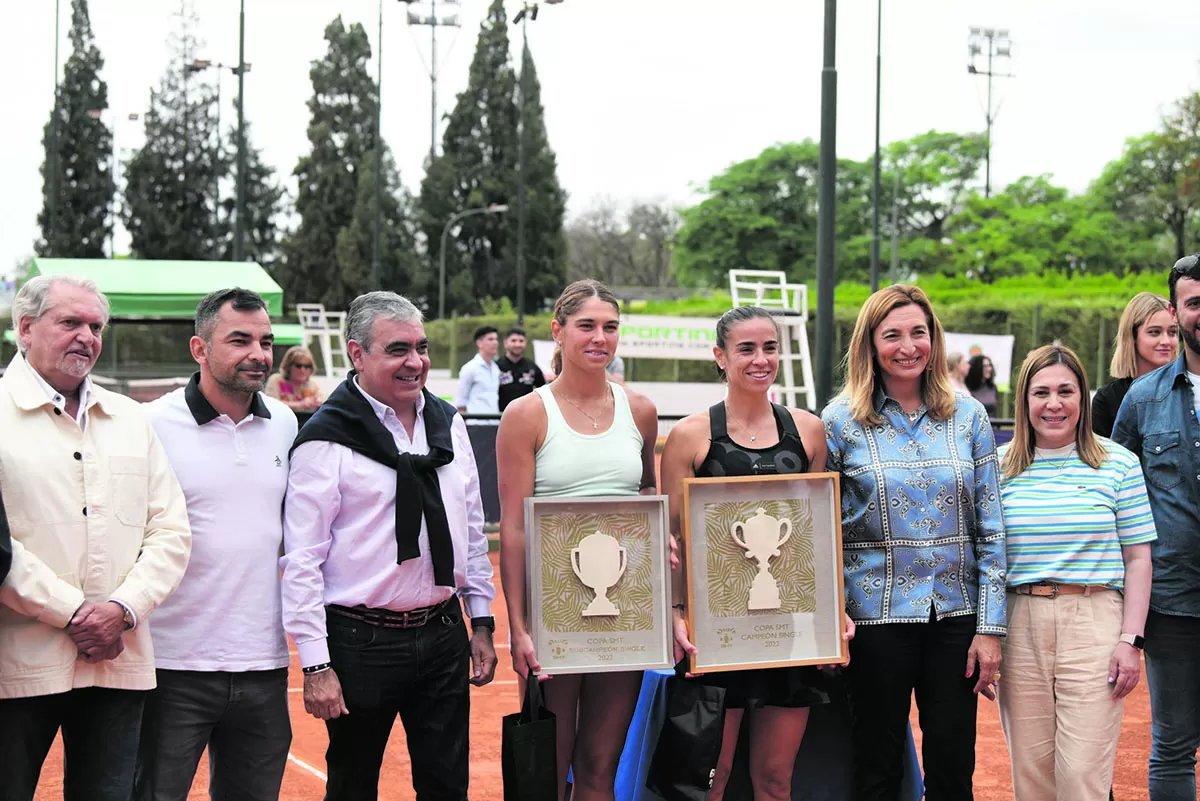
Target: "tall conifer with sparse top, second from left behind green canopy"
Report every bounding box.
[121,7,229,260]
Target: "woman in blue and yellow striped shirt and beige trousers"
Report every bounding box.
[1000,345,1156,801]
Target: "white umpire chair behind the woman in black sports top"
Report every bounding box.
[730,270,817,411]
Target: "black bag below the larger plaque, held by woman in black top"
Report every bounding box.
[646,676,725,801]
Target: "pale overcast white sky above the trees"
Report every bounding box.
[0,0,1200,281]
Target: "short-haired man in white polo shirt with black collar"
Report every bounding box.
[134,289,296,801]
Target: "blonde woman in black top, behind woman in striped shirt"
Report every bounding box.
[1092,293,1180,436]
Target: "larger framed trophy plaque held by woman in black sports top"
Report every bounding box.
[680,472,846,673]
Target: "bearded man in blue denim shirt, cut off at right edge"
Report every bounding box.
[1112,253,1200,801]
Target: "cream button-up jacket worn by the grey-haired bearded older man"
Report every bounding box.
[0,355,192,698]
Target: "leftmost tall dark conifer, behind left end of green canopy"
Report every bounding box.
[35,0,115,259]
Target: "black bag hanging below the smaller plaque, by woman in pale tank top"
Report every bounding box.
[500,675,560,801]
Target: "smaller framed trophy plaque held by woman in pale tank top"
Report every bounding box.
[526,495,674,675]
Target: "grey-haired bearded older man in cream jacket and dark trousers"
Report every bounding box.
[0,276,191,801]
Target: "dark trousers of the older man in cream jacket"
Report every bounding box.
[0,687,146,801]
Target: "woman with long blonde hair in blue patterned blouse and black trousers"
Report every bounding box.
[822,284,1007,801]
